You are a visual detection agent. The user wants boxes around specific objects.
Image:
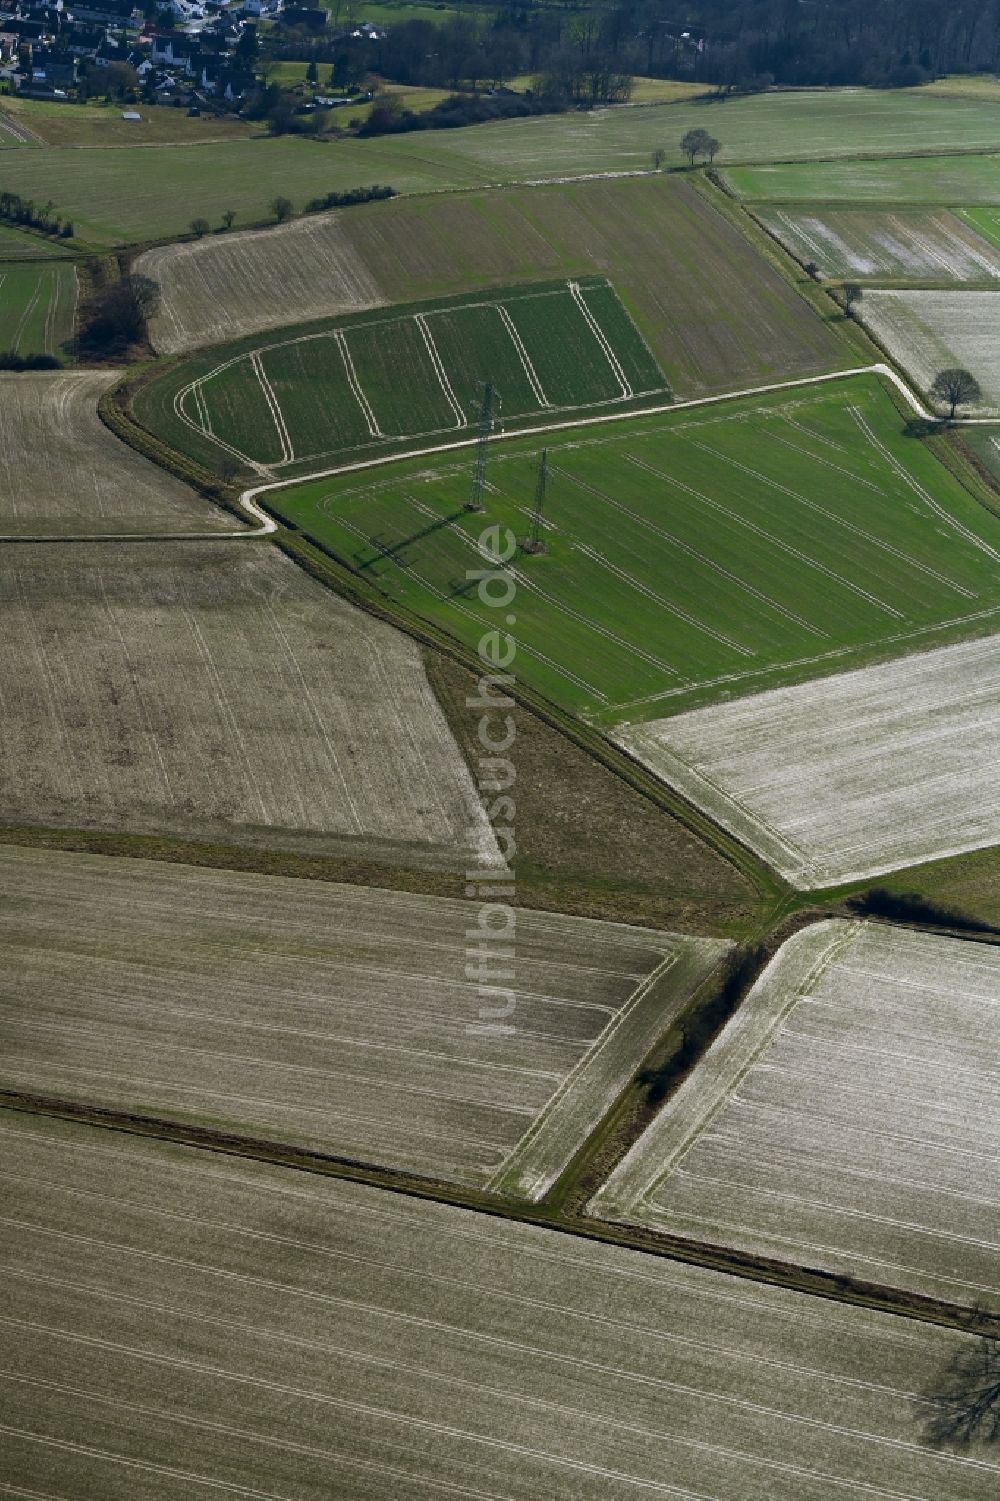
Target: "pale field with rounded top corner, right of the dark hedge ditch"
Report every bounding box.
[593,922,1000,1307]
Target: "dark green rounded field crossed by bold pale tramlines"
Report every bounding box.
[174,278,667,471]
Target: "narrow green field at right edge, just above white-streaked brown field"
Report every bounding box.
[724,153,1000,206]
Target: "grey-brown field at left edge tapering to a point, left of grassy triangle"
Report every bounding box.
[0,540,498,869]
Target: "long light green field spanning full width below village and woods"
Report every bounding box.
[5,89,1000,243]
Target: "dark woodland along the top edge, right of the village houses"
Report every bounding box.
[278,0,1000,108]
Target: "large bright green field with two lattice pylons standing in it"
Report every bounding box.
[270,377,1000,725]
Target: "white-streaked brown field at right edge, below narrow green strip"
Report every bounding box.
[757,207,1000,282]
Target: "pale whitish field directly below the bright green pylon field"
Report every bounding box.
[614,635,1000,889]
